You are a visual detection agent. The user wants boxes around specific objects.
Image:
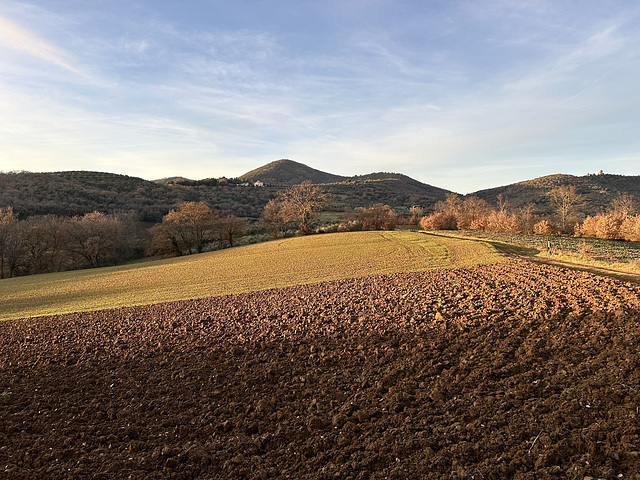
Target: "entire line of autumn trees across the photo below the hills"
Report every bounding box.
[0,181,640,278]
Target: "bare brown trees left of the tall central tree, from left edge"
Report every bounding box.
[0,202,246,278]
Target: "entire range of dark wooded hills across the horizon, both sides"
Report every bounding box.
[0,160,640,222]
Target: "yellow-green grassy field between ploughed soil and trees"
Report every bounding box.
[0,231,502,320]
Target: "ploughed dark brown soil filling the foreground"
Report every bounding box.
[0,260,640,480]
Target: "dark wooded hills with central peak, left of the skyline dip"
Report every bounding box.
[0,160,448,222]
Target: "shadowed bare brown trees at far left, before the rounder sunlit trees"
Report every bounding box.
[0,207,145,278]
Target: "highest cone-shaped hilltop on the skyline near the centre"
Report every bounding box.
[239,159,348,186]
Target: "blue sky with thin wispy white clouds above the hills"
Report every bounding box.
[0,0,640,193]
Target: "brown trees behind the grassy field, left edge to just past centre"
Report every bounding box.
[0,182,398,278]
